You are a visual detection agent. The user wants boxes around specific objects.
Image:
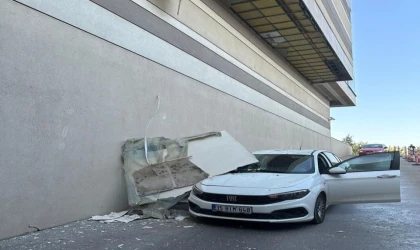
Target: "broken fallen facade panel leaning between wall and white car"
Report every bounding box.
[122,131,257,206]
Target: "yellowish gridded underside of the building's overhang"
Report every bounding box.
[220,0,352,83]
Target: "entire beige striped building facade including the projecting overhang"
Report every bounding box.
[0,0,356,238]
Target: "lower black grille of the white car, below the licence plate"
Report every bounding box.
[189,201,308,220]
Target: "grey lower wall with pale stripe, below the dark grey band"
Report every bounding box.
[0,0,352,238]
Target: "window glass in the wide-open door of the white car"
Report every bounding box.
[338,153,394,173]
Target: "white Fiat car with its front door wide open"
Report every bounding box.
[188,150,401,224]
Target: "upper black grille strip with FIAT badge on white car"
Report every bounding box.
[198,193,284,205]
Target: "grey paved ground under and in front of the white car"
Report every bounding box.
[0,160,420,250]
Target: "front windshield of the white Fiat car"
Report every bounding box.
[236,154,315,174]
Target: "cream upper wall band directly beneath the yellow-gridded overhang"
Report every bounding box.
[147,0,330,118]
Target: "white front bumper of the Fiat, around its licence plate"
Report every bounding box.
[188,193,316,223]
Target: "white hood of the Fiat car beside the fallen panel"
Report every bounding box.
[201,173,312,188]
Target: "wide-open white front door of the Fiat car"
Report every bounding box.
[322,152,401,204]
